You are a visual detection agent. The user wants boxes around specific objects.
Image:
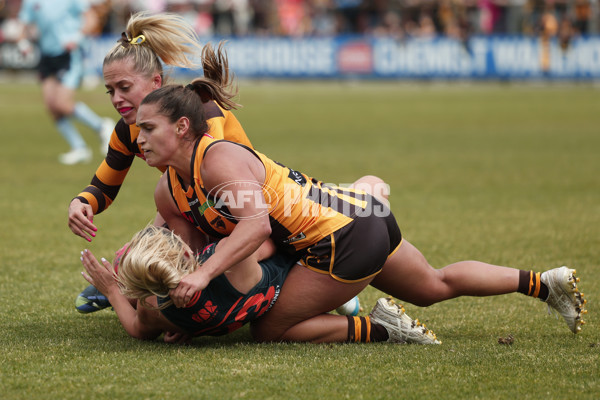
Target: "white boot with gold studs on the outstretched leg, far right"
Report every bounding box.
[540,267,587,333]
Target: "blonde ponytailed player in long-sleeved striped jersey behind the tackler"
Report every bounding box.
[69,13,252,241]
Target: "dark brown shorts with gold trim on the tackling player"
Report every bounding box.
[300,199,402,283]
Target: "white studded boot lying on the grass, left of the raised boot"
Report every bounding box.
[369,298,442,344]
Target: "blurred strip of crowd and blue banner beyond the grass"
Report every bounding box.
[0,0,600,81]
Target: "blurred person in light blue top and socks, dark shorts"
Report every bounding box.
[18,0,114,165]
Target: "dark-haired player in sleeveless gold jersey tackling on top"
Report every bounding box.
[127,80,585,341]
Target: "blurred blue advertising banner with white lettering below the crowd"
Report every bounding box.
[3,36,600,80]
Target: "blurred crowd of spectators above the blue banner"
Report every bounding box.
[0,0,600,41]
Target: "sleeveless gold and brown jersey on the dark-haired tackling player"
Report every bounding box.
[168,135,368,252]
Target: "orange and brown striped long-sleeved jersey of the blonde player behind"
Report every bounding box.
[77,101,252,214]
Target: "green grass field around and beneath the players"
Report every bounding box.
[0,81,600,399]
